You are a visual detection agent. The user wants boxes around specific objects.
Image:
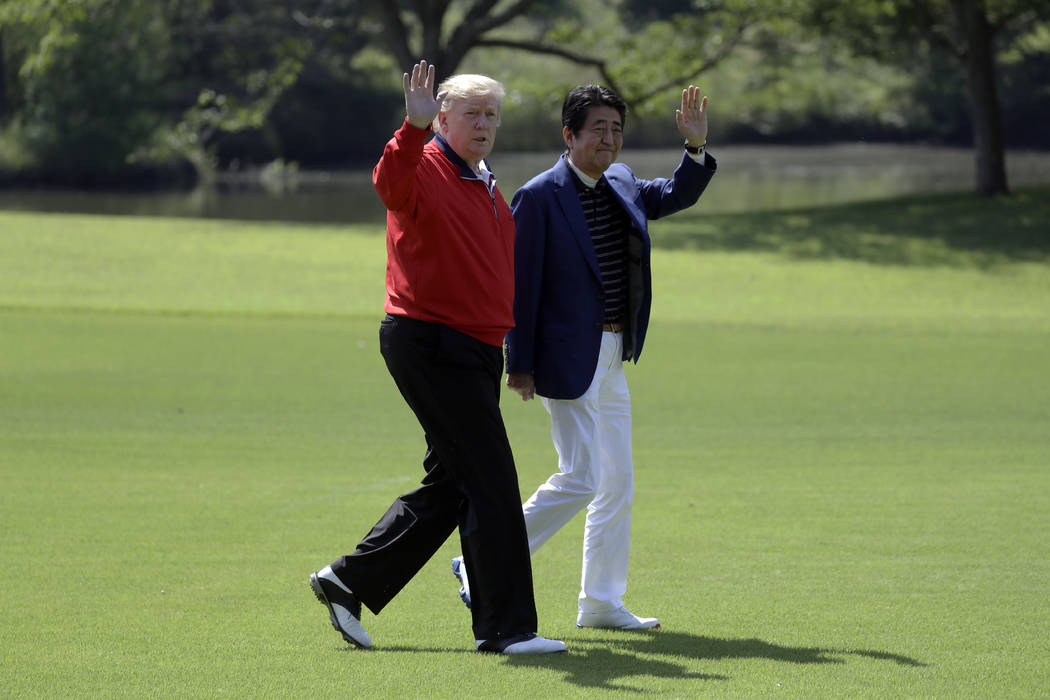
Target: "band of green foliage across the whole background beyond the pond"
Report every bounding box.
[0,0,1050,182]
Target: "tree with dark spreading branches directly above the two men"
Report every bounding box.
[348,0,768,107]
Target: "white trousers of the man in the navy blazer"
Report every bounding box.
[522,333,634,612]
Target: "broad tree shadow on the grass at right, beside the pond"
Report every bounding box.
[652,187,1050,269]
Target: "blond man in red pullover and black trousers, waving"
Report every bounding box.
[310,61,565,654]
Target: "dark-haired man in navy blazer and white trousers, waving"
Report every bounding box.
[453,85,717,630]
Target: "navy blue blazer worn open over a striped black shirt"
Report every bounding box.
[506,154,717,399]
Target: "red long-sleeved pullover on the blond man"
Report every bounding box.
[372,120,515,346]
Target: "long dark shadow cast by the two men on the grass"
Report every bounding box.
[507,631,927,693]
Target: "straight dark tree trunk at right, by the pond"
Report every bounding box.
[951,0,1009,196]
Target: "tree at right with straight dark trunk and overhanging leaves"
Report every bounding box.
[811,0,1050,196]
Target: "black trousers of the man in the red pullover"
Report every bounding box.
[332,315,537,639]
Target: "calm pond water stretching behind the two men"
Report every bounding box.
[0,144,1050,222]
